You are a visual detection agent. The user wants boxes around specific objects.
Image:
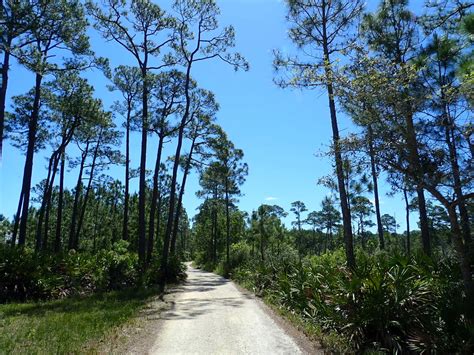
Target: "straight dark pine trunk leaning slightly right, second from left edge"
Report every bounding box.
[18,73,43,245]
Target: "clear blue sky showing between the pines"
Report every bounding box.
[0,0,416,229]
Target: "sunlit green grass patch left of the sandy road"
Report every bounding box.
[0,289,157,354]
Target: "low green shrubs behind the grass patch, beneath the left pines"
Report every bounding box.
[0,241,174,302]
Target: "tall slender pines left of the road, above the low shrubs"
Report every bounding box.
[0,0,248,286]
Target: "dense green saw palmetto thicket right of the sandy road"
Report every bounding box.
[234,249,469,353]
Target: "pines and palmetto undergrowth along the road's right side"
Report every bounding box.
[191,0,474,353]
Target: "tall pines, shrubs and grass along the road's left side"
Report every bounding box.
[0,0,244,353]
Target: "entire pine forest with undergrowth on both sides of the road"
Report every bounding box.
[0,0,474,354]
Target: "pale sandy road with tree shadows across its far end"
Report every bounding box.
[151,266,308,355]
